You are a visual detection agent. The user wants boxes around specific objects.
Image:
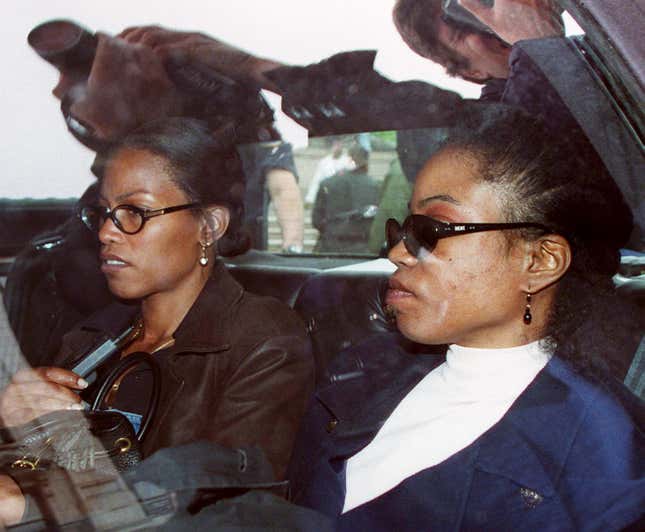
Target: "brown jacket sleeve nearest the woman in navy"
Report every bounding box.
[207,335,314,479]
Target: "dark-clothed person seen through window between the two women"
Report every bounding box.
[311,144,379,253]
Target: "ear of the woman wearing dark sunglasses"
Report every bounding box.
[522,235,571,293]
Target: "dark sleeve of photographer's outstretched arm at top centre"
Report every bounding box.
[266,50,462,135]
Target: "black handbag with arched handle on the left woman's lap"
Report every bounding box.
[0,352,160,472]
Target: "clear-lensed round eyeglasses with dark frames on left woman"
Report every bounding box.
[79,203,200,235]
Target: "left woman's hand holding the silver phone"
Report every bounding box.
[0,367,87,427]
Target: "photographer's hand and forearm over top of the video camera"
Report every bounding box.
[119,26,281,90]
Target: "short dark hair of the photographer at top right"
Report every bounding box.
[392,0,470,79]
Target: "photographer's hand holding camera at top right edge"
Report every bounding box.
[459,0,564,44]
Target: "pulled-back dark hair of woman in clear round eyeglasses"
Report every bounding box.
[94,118,250,256]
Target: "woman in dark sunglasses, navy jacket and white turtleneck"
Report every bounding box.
[289,112,645,531]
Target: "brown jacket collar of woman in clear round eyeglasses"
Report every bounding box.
[82,260,244,353]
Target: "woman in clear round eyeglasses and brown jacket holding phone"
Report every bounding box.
[0,119,313,478]
